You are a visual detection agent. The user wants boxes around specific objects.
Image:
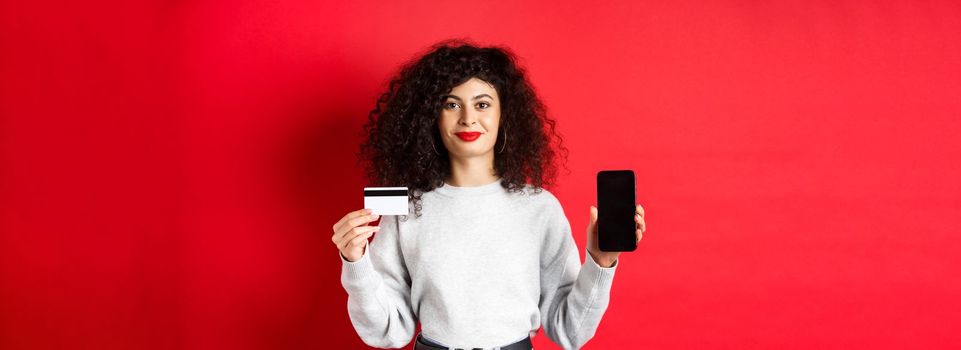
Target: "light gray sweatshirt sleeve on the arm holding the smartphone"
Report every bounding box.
[539,199,617,349]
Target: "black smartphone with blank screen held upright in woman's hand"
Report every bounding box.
[597,170,637,252]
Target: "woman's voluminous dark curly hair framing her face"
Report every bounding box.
[358,39,567,217]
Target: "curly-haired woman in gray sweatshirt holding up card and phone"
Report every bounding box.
[332,42,644,349]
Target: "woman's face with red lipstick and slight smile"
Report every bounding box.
[437,78,501,158]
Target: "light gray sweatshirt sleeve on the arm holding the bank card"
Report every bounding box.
[338,216,417,348]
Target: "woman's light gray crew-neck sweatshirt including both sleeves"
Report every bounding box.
[341,180,617,349]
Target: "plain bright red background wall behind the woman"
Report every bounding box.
[0,1,961,349]
